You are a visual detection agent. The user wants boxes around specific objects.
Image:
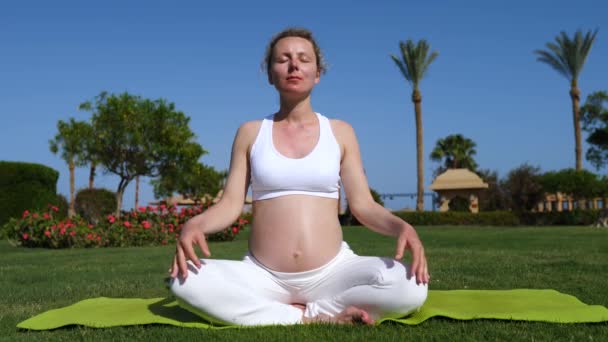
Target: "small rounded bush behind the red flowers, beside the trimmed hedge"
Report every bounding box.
[74,188,116,224]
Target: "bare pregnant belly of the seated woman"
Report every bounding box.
[249,195,342,272]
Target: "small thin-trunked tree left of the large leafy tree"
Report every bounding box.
[49,118,90,217]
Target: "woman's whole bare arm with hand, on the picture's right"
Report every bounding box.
[332,120,430,284]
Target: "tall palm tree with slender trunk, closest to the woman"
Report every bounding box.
[391,39,439,211]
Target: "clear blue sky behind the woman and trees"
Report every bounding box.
[0,0,608,209]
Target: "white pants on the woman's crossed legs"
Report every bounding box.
[171,242,427,325]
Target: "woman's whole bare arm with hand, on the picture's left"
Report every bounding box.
[170,121,259,279]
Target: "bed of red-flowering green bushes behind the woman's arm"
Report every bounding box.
[3,205,248,248]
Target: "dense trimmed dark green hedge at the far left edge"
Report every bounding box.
[0,161,59,226]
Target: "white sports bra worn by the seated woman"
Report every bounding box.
[250,113,340,201]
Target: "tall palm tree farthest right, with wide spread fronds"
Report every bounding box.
[534,30,597,170]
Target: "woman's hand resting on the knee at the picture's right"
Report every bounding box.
[395,223,431,284]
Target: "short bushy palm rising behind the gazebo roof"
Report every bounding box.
[430,134,477,172]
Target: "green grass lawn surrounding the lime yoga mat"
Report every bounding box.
[0,227,608,341]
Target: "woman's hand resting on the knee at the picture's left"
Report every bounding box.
[170,218,211,279]
